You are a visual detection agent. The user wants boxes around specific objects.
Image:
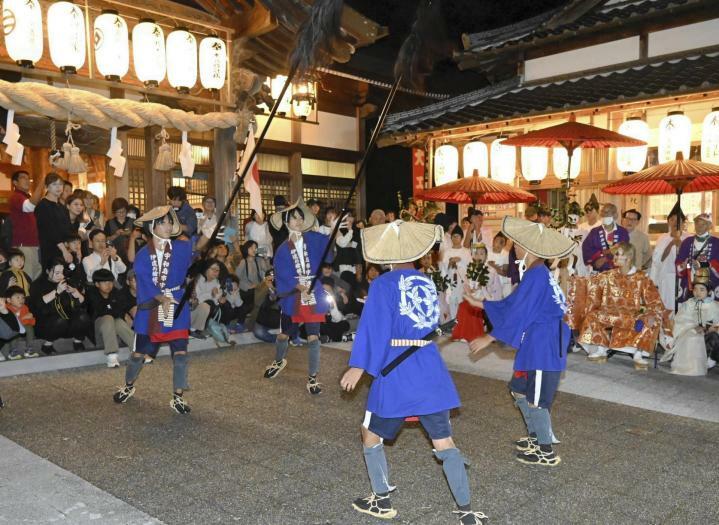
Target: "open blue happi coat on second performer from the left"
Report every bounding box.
[273,232,331,316]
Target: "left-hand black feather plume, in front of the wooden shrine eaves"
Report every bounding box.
[290,0,344,77]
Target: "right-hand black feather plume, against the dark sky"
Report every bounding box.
[394,0,452,91]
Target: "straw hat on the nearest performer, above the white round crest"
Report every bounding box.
[360,220,444,264]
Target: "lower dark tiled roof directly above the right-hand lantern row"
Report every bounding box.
[383,52,719,135]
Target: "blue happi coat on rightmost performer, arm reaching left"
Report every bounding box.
[484,260,570,371]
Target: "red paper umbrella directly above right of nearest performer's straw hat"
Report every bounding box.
[422,170,537,205]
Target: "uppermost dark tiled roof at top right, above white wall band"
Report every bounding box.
[465,0,696,54]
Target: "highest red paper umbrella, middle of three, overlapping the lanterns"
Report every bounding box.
[502,113,646,189]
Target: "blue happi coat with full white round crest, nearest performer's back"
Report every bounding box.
[349,270,460,417]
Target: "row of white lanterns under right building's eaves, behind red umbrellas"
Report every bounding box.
[434,108,719,186]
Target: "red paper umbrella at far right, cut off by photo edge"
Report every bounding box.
[602,151,719,310]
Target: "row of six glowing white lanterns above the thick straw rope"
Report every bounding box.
[2,0,227,93]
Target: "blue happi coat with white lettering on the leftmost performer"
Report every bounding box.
[133,239,192,335]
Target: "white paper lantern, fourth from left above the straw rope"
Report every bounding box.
[132,18,165,87]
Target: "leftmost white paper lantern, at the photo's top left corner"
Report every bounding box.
[2,0,43,67]
